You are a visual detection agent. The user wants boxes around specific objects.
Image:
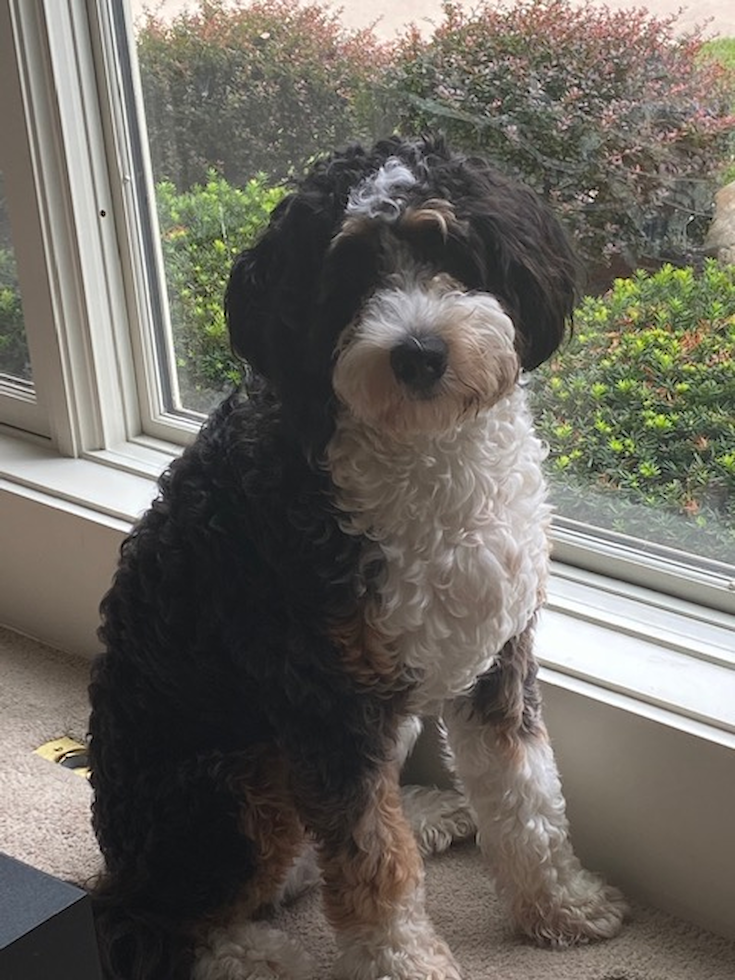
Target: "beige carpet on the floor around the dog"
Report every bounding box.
[0,629,735,980]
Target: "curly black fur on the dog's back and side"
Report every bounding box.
[90,384,414,980]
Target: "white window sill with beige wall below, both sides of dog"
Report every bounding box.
[0,433,735,936]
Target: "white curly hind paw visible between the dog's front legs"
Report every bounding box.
[401,786,477,856]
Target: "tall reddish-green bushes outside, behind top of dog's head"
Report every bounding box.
[138,0,735,276]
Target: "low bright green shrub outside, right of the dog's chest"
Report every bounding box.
[533,260,735,560]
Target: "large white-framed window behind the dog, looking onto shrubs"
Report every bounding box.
[0,0,735,610]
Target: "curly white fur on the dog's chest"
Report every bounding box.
[328,388,550,711]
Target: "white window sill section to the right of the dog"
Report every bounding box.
[537,563,735,746]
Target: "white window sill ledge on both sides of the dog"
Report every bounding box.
[0,432,735,736]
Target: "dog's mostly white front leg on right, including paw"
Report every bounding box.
[444,627,626,946]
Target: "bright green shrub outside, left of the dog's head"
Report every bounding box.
[156,172,285,410]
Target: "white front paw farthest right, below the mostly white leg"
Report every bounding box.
[514,871,628,947]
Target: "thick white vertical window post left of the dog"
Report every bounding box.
[11,0,138,455]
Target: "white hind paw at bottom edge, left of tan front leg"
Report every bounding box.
[191,922,313,980]
